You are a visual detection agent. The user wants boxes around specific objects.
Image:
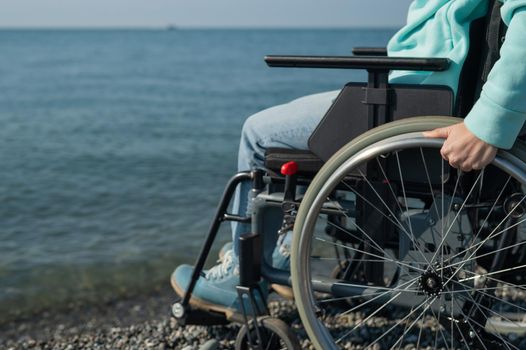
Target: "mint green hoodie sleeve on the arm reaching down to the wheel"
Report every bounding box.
[464,4,526,149]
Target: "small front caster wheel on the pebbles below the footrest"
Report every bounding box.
[235,316,301,350]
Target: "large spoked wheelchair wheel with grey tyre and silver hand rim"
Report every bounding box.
[291,117,526,349]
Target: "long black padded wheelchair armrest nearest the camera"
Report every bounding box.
[265,55,450,71]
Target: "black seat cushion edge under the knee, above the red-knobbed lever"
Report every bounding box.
[265,148,323,176]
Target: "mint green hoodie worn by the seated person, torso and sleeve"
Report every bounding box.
[388,0,526,149]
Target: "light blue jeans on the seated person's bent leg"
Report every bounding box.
[232,90,339,254]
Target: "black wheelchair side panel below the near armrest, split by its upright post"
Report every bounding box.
[309,83,453,161]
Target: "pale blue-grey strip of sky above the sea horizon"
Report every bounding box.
[0,0,411,28]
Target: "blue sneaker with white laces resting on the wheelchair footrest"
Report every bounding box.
[171,250,266,319]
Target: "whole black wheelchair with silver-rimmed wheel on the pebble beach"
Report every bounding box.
[172,3,526,350]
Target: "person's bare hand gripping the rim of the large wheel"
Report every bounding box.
[424,123,497,172]
